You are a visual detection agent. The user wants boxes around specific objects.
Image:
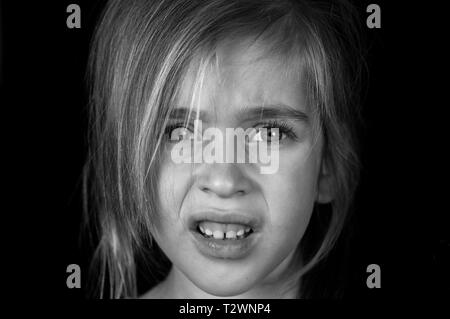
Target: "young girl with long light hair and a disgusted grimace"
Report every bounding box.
[84,0,361,298]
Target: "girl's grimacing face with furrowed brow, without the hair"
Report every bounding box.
[154,40,325,296]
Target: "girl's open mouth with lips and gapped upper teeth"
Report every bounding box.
[188,212,261,259]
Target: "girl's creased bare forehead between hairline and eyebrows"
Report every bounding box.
[177,37,306,115]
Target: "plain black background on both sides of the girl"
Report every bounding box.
[1,0,450,299]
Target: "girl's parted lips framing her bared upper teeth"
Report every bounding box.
[188,211,262,259]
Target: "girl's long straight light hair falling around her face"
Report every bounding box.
[84,0,361,298]
